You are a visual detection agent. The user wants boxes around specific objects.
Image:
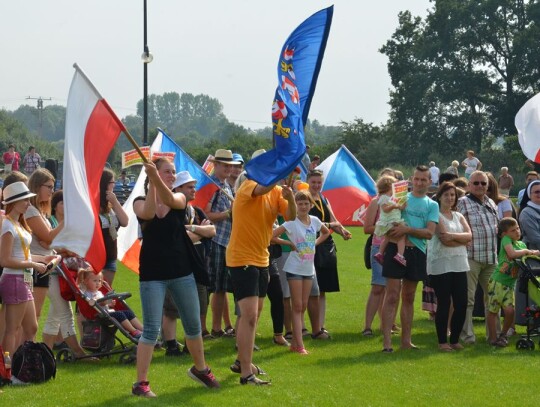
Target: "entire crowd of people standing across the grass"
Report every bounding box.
[0,149,540,397]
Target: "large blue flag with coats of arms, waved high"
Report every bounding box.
[246,6,334,186]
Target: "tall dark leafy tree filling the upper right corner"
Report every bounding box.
[381,0,540,159]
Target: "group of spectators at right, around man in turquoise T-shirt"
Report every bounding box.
[362,155,540,353]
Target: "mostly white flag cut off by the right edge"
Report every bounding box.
[515,93,540,163]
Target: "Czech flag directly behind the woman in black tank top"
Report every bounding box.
[117,129,219,273]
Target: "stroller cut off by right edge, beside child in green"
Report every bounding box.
[516,256,540,350]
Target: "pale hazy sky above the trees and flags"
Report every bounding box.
[0,0,432,129]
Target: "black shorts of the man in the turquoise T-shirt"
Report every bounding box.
[383,243,427,281]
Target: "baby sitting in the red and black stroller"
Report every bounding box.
[77,268,143,339]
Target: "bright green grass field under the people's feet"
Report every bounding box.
[0,228,540,406]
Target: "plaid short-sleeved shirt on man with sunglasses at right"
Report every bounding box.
[457,194,498,264]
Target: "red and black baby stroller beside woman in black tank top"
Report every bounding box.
[56,258,138,364]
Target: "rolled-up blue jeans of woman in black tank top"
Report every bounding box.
[139,274,201,345]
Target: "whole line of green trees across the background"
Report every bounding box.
[0,0,540,185]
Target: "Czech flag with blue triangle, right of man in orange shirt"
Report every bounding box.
[317,145,377,226]
